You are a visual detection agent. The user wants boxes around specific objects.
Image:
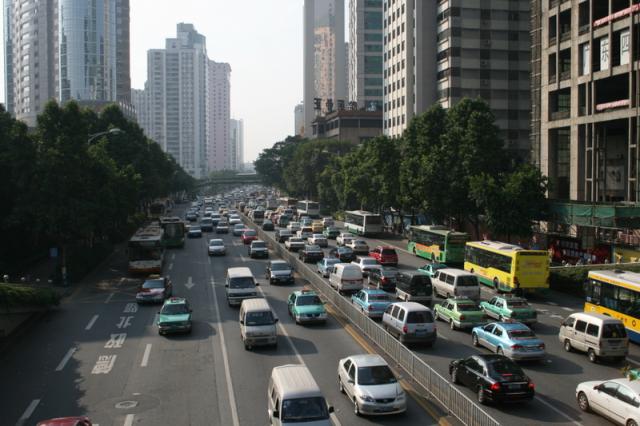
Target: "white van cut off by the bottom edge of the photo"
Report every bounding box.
[267,364,333,426]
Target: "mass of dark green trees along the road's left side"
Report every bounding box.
[0,101,195,278]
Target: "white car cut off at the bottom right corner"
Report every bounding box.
[576,378,640,426]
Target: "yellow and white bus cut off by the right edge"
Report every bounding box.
[584,269,640,343]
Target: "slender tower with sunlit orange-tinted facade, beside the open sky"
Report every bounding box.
[303,0,348,136]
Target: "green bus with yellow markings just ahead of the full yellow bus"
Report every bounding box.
[407,225,469,265]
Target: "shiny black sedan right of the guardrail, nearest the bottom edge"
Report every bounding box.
[449,354,535,404]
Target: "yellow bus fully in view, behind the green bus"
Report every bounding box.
[464,241,549,292]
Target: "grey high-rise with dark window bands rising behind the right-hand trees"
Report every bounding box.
[384,0,531,158]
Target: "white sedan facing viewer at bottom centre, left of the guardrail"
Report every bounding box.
[338,354,407,415]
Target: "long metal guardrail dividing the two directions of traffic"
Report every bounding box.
[247,218,500,426]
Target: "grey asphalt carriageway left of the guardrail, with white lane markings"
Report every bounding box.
[0,209,436,426]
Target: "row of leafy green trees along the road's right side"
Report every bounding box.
[255,98,548,238]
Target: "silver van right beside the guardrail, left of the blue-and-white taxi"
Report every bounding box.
[382,302,438,346]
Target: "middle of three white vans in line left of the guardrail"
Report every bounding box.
[240,299,278,350]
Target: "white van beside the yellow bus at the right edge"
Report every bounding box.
[558,312,629,362]
